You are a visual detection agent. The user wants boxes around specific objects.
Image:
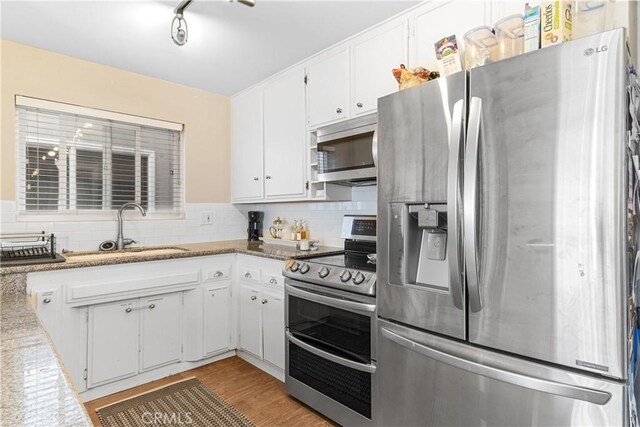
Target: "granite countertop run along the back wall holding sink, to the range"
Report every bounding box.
[0,240,343,275]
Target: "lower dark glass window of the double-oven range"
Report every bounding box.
[289,343,371,419]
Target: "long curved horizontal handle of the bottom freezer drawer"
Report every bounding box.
[381,328,611,405]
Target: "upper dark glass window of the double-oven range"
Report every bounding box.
[288,295,371,364]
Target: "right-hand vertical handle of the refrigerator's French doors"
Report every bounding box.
[463,97,482,312]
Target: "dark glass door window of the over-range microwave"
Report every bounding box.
[318,132,375,173]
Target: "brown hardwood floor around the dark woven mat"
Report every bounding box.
[85,356,335,427]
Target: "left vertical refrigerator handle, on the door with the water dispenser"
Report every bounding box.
[447,99,464,310]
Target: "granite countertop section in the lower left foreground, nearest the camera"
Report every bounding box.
[0,274,93,426]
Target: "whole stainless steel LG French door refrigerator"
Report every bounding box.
[375,29,636,426]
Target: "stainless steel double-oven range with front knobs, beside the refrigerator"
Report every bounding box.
[284,216,377,426]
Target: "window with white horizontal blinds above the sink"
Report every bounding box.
[16,97,183,214]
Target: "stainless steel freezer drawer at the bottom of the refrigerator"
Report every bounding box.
[374,321,629,426]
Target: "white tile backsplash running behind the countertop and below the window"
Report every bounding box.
[0,186,376,251]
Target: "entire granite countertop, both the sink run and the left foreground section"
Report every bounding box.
[0,240,342,426]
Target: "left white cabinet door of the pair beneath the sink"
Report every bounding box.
[87,299,139,388]
